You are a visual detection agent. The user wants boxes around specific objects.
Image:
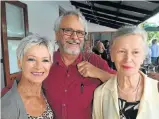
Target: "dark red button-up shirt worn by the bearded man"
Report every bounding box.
[44,51,115,119]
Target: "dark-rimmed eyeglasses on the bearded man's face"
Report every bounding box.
[60,28,87,38]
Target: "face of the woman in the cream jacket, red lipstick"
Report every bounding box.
[111,34,145,76]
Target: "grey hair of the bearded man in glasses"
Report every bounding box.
[54,10,88,34]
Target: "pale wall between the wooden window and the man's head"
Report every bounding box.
[22,1,59,40]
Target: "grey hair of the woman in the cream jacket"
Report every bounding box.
[110,25,148,55]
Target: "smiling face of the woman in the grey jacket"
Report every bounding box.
[18,45,52,83]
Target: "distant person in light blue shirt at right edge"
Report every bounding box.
[151,39,159,65]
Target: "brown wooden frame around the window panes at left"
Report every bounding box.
[1,1,29,86]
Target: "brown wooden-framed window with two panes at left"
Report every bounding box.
[1,1,28,86]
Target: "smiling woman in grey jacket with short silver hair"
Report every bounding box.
[1,35,53,119]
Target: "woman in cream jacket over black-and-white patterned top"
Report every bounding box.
[93,26,159,119]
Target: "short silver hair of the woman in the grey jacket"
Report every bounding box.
[16,34,53,61]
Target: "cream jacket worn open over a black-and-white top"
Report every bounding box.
[92,73,159,119]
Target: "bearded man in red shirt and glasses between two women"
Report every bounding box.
[44,11,116,119]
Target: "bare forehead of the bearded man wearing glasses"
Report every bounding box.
[60,15,84,31]
